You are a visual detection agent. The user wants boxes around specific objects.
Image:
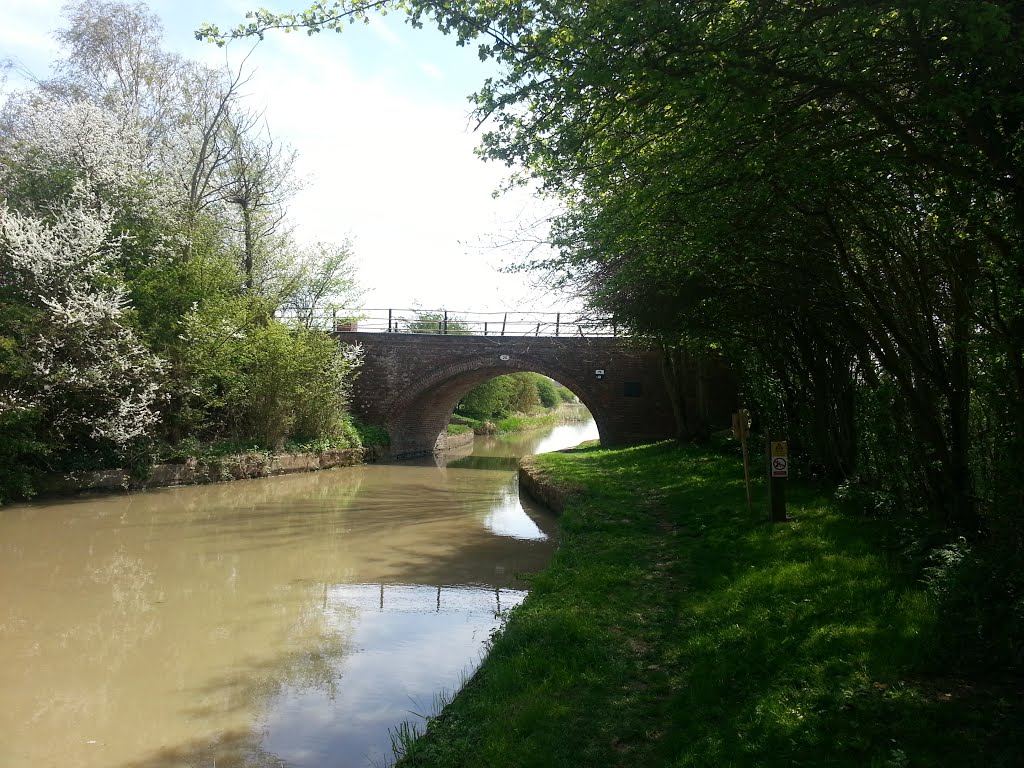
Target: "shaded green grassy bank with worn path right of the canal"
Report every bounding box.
[399,443,1024,768]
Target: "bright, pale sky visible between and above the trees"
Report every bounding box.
[0,0,571,311]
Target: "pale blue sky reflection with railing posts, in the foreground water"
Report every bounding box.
[266,585,525,766]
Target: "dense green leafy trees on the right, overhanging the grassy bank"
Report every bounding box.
[204,0,1024,541]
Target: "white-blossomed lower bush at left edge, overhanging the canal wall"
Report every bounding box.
[0,185,164,445]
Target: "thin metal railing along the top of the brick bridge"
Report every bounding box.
[276,309,620,338]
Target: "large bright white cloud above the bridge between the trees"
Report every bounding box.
[239,29,552,309]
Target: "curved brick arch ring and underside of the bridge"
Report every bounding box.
[384,353,608,455]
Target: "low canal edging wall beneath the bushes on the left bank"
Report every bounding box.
[40,446,382,496]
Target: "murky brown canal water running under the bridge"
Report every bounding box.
[0,422,597,768]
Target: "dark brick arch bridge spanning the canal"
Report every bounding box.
[339,333,735,458]
